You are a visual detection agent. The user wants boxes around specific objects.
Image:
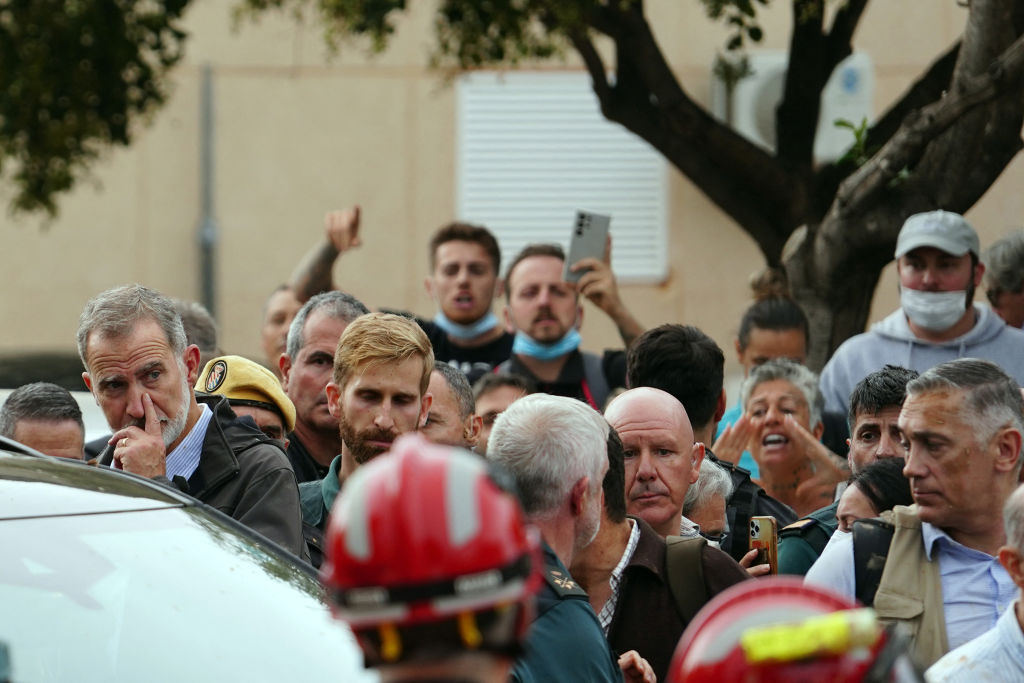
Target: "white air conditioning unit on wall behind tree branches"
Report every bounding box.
[712,50,874,163]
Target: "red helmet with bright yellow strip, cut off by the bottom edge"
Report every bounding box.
[668,577,923,683]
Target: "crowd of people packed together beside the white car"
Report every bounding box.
[6,208,1024,681]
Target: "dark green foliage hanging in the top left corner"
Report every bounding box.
[0,0,188,215]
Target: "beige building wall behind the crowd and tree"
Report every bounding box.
[0,0,1024,397]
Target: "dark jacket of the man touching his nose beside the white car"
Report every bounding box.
[99,395,306,557]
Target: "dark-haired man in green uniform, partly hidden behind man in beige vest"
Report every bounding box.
[778,366,918,575]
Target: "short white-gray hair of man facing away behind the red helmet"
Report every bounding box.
[486,393,609,519]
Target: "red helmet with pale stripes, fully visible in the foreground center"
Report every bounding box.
[321,434,542,666]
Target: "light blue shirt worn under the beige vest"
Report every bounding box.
[806,522,1017,649]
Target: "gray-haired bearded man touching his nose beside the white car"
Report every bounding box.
[78,285,305,555]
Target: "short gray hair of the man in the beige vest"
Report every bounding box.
[906,358,1024,456]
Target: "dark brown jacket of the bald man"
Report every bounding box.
[608,517,750,681]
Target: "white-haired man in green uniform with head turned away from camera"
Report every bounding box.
[486,394,650,683]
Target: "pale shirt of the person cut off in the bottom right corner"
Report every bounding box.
[925,603,1024,683]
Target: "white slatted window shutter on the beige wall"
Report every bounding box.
[456,72,668,283]
